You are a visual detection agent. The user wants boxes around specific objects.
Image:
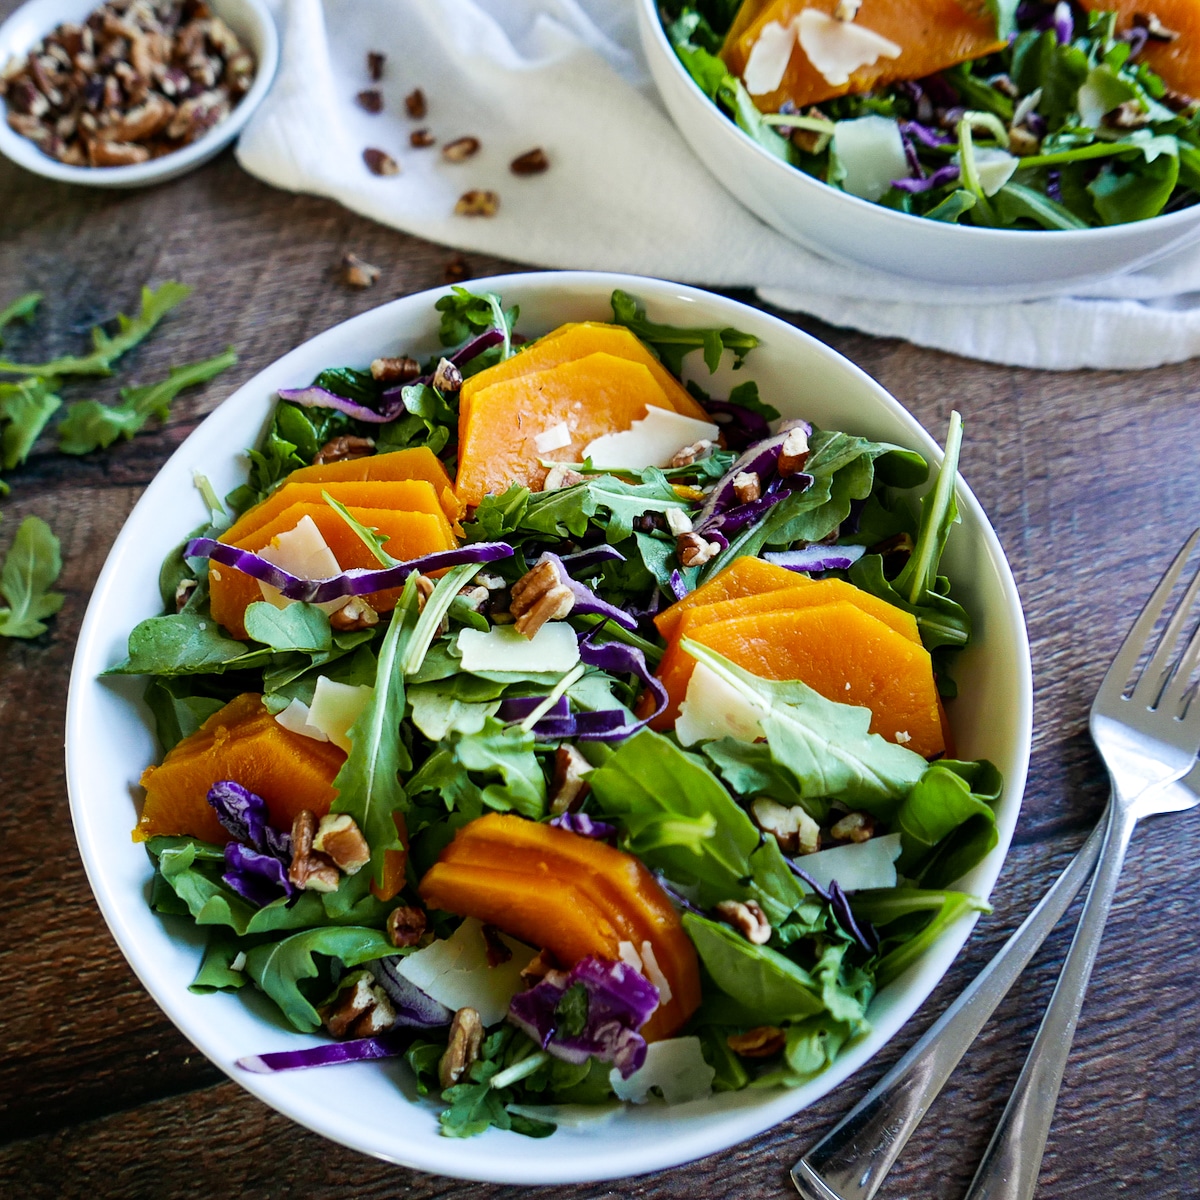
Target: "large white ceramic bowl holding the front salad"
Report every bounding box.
[66,272,1032,1184]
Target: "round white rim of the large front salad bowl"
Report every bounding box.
[65,271,1033,1186]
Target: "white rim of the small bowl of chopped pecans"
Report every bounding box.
[0,0,280,187]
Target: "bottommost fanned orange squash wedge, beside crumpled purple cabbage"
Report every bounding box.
[419,814,700,1040]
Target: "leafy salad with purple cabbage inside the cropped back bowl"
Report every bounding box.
[661,0,1200,230]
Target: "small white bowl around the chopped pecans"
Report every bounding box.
[0,0,280,187]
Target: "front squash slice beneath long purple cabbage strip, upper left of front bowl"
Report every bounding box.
[209,502,455,640]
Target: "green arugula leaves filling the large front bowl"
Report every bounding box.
[124,285,1000,1136]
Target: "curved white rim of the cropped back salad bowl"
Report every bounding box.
[640,0,1200,246]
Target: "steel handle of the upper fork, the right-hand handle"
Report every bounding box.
[966,800,1138,1200]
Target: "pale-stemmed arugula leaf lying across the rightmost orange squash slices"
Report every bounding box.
[680,638,928,820]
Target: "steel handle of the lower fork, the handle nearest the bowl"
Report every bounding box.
[792,821,1104,1200]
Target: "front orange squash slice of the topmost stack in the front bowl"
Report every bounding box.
[455,353,674,505]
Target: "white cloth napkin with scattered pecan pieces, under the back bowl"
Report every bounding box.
[238,0,1200,370]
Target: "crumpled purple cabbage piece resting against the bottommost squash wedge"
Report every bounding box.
[509,955,659,1079]
